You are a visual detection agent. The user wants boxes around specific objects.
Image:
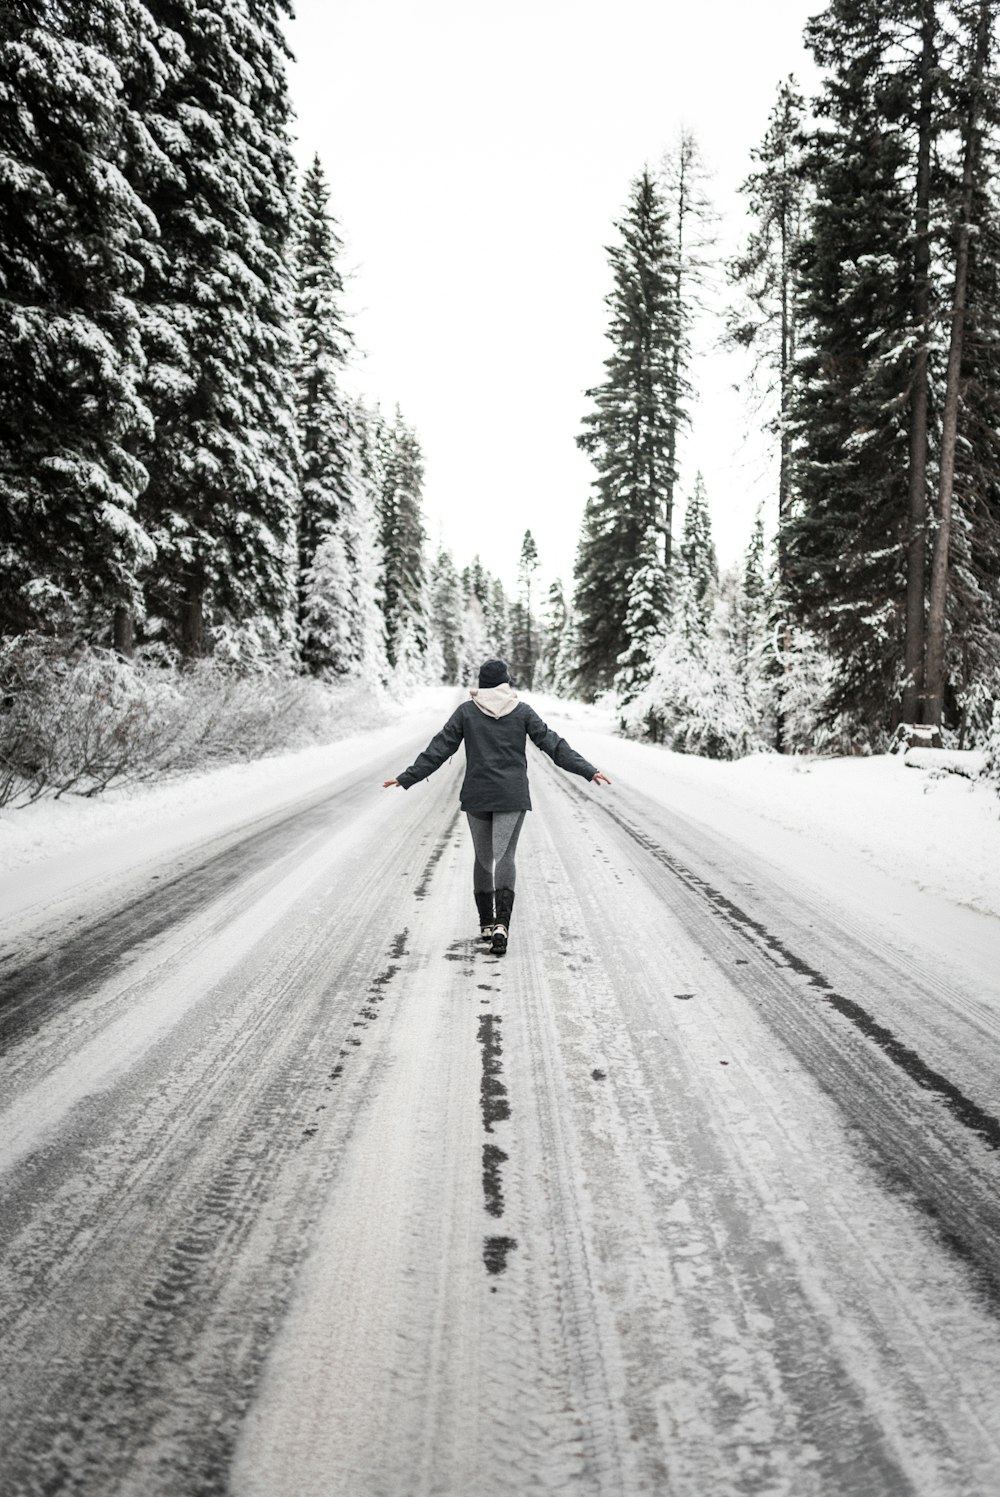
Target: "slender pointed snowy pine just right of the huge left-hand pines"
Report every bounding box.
[293,156,354,674]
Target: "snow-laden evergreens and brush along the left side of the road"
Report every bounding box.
[0,0,553,802]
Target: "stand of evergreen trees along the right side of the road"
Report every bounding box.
[576,0,1000,754]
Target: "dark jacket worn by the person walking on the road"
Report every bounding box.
[397,701,597,811]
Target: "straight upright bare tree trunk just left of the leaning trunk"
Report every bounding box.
[901,3,937,723]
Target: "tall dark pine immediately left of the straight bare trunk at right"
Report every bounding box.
[783,0,915,737]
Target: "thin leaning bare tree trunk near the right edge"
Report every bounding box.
[924,0,991,728]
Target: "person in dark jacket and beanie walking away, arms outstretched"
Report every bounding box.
[382,660,611,954]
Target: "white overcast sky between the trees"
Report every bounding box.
[279,0,822,595]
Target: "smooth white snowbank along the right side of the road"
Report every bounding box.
[536,698,1000,916]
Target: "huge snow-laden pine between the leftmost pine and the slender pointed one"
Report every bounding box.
[141,0,298,656]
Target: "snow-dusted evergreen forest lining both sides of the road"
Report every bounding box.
[0,0,1000,793]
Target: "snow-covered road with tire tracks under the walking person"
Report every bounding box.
[0,718,1000,1497]
